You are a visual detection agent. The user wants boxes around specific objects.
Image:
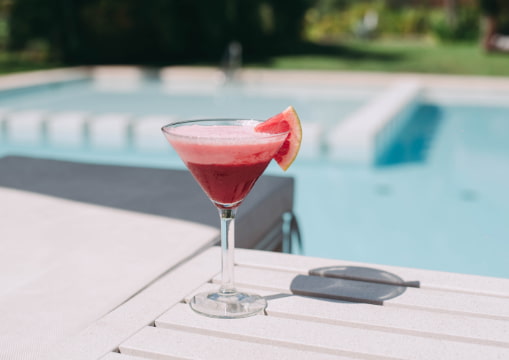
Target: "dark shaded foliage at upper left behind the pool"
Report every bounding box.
[9,0,310,64]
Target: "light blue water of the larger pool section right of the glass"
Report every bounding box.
[293,104,509,277]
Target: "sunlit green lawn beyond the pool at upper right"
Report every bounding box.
[247,40,509,76]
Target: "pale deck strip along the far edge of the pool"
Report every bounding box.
[0,66,509,93]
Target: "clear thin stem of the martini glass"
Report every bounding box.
[219,209,237,294]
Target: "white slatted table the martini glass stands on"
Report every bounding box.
[54,248,509,360]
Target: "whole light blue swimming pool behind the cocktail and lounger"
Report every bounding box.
[0,67,509,277]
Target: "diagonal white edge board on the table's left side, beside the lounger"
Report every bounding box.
[49,247,220,360]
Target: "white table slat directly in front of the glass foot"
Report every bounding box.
[156,304,509,359]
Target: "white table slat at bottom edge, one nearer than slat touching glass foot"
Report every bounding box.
[120,326,346,360]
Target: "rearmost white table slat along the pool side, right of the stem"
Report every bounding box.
[235,249,509,298]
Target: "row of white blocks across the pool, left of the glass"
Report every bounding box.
[0,108,178,152]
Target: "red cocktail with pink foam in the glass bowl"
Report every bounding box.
[166,120,284,208]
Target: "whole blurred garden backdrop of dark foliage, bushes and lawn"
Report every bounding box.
[0,0,509,75]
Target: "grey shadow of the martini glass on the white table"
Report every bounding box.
[268,266,420,305]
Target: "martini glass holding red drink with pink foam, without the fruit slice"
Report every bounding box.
[162,119,288,318]
